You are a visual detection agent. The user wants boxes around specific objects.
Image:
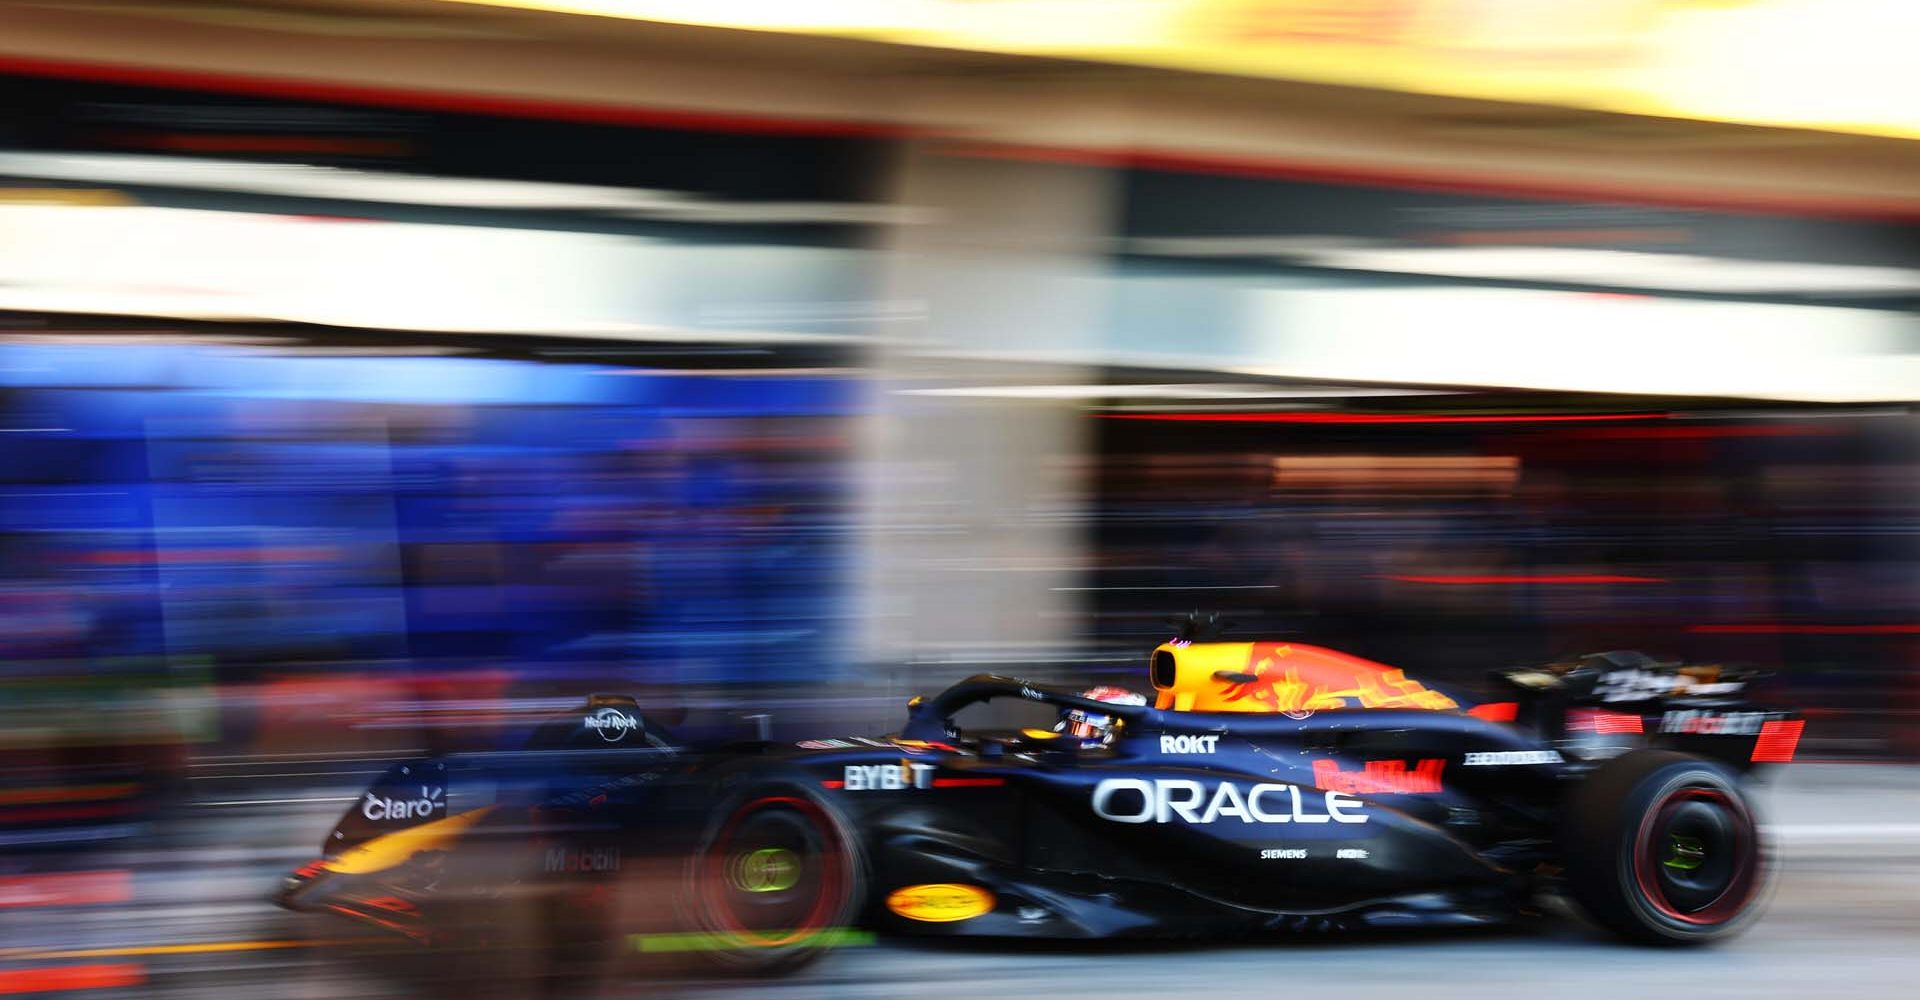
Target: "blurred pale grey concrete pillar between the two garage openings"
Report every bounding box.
[858,144,1116,689]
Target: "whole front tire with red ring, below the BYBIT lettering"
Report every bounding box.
[685,781,864,975]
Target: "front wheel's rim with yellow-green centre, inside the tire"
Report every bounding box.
[703,797,847,948]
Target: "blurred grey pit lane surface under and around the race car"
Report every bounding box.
[0,766,1920,1000]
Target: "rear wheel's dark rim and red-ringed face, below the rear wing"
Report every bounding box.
[1634,787,1761,927]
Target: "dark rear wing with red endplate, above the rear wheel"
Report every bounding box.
[1494,651,1807,770]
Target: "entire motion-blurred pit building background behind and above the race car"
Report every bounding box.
[0,0,1920,996]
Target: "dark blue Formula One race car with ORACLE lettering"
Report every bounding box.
[280,639,1803,971]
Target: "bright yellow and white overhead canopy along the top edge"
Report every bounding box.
[455,0,1920,138]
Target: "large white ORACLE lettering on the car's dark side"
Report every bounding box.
[1092,777,1367,823]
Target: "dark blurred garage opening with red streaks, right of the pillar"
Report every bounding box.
[1089,409,1920,756]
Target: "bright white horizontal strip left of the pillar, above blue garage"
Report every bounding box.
[0,205,858,344]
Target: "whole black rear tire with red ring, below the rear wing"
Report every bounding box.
[1561,750,1772,944]
